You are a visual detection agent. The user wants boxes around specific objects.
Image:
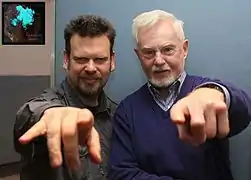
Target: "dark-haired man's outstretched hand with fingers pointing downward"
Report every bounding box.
[19,107,101,169]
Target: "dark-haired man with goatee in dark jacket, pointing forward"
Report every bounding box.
[14,15,116,180]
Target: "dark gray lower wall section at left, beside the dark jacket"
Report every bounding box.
[0,76,50,165]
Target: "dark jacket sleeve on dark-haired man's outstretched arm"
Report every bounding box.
[13,89,64,180]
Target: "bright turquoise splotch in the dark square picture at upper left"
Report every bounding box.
[11,5,35,29]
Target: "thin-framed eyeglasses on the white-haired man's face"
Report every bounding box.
[140,46,178,59]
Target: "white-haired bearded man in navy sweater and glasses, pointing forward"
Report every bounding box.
[109,10,251,180]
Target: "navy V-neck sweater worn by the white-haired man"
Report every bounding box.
[109,76,251,180]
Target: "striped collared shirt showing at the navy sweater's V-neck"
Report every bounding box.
[148,71,186,111]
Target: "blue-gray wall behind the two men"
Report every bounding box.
[55,0,251,180]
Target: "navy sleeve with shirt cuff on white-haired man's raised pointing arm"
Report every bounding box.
[197,78,251,137]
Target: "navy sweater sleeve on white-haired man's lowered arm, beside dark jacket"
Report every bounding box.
[108,102,173,180]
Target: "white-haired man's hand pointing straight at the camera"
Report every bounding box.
[170,88,229,145]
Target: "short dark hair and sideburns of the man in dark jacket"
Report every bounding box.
[64,15,116,55]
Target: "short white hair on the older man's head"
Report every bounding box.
[132,10,185,43]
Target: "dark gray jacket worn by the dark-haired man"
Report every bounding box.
[14,80,117,180]
